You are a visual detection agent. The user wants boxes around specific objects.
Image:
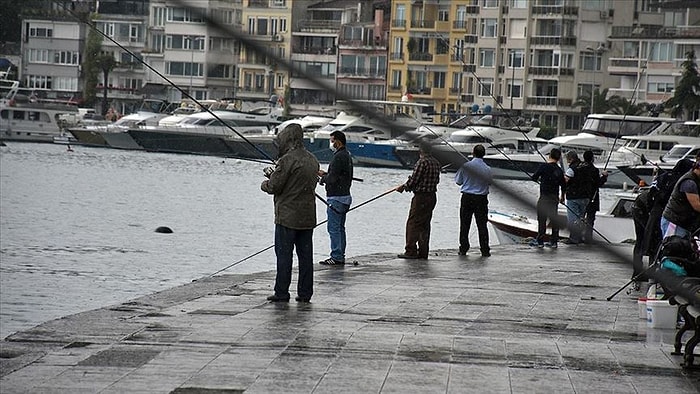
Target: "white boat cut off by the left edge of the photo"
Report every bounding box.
[0,71,79,142]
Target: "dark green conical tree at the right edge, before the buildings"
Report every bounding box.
[664,50,700,120]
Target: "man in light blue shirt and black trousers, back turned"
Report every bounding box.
[455,145,493,257]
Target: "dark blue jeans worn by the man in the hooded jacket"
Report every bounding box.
[275,224,314,299]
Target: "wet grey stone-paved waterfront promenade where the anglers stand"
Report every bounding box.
[0,245,700,394]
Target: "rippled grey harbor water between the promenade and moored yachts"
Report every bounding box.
[0,142,615,338]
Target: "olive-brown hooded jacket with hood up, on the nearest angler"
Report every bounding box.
[260,124,319,230]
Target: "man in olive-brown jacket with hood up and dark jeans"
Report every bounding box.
[260,124,319,302]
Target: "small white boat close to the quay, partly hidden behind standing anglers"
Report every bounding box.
[488,192,637,243]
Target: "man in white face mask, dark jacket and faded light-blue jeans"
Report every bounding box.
[318,131,352,265]
